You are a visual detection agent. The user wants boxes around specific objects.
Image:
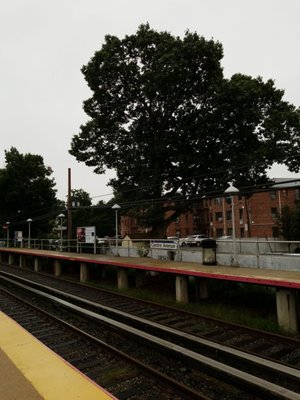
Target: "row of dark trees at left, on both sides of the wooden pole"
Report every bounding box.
[0,147,114,239]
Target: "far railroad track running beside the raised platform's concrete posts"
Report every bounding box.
[1,266,300,369]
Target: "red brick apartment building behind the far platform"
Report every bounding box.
[121,179,300,238]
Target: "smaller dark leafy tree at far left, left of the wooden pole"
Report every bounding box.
[0,147,60,237]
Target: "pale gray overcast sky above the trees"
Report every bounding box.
[0,0,300,202]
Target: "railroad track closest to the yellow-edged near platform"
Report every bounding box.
[0,287,209,400]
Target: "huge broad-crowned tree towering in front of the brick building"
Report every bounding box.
[70,25,299,234]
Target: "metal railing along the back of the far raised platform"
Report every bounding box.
[0,238,300,270]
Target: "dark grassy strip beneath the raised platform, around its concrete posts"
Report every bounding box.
[87,273,298,335]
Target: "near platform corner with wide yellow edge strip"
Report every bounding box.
[0,312,115,400]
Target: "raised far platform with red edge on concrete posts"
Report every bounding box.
[0,248,300,332]
